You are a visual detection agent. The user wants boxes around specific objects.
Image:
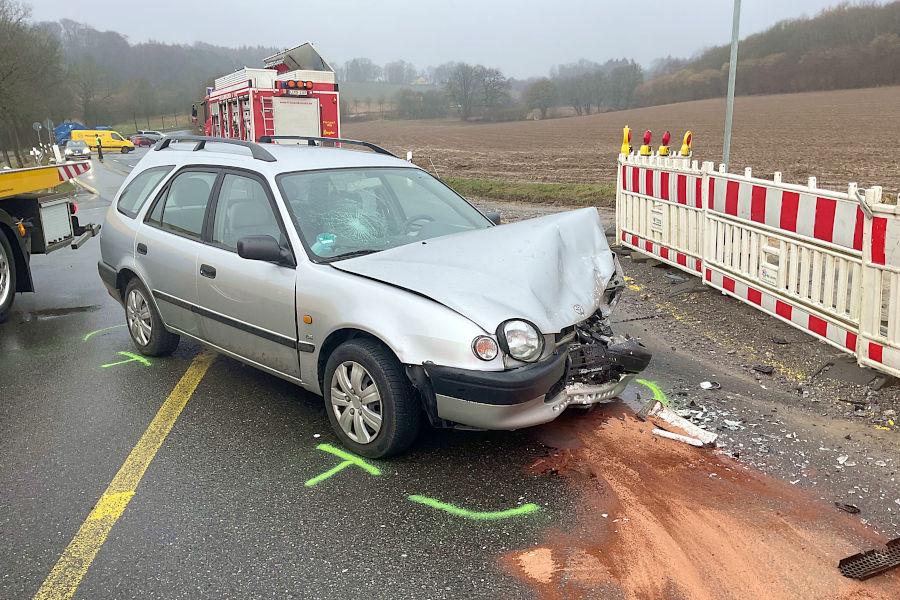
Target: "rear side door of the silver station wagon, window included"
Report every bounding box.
[135,167,220,336]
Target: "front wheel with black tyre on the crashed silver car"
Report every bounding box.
[323,339,421,458]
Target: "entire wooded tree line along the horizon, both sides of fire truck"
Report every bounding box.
[0,0,900,164]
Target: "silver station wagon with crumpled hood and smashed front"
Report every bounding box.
[98,136,650,457]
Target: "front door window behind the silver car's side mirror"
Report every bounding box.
[212,173,285,252]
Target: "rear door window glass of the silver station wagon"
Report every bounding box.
[147,171,216,239]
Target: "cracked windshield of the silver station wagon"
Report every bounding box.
[278,168,491,261]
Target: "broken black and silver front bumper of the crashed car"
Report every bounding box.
[426,340,650,429]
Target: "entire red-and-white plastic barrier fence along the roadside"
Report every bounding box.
[616,154,900,376]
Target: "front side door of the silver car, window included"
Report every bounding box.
[197,171,300,379]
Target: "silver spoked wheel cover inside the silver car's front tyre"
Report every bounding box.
[331,360,383,444]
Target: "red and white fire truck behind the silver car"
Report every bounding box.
[203,42,341,142]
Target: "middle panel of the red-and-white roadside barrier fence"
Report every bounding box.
[704,169,865,353]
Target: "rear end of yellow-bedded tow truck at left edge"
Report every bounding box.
[0,161,100,323]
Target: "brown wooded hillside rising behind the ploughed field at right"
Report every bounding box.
[635,2,900,106]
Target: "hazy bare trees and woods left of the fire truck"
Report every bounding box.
[0,0,278,166]
